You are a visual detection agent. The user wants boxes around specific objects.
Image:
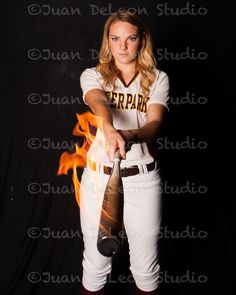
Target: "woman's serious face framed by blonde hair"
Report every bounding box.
[109,21,140,64]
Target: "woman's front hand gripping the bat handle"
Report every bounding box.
[103,126,126,162]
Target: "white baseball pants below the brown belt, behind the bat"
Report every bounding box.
[80,164,161,292]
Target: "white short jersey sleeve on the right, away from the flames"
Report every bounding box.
[148,71,170,111]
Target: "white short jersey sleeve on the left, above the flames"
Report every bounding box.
[80,67,103,105]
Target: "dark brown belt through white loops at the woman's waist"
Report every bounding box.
[87,160,158,177]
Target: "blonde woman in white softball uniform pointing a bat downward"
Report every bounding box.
[80,10,169,295]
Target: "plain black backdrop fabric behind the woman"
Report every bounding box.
[0,0,231,295]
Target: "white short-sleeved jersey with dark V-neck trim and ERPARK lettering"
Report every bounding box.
[80,67,169,167]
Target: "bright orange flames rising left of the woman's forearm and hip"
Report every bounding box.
[57,112,103,207]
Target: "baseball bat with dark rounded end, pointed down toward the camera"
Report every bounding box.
[97,150,124,257]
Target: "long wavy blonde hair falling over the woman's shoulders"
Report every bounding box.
[96,9,157,95]
